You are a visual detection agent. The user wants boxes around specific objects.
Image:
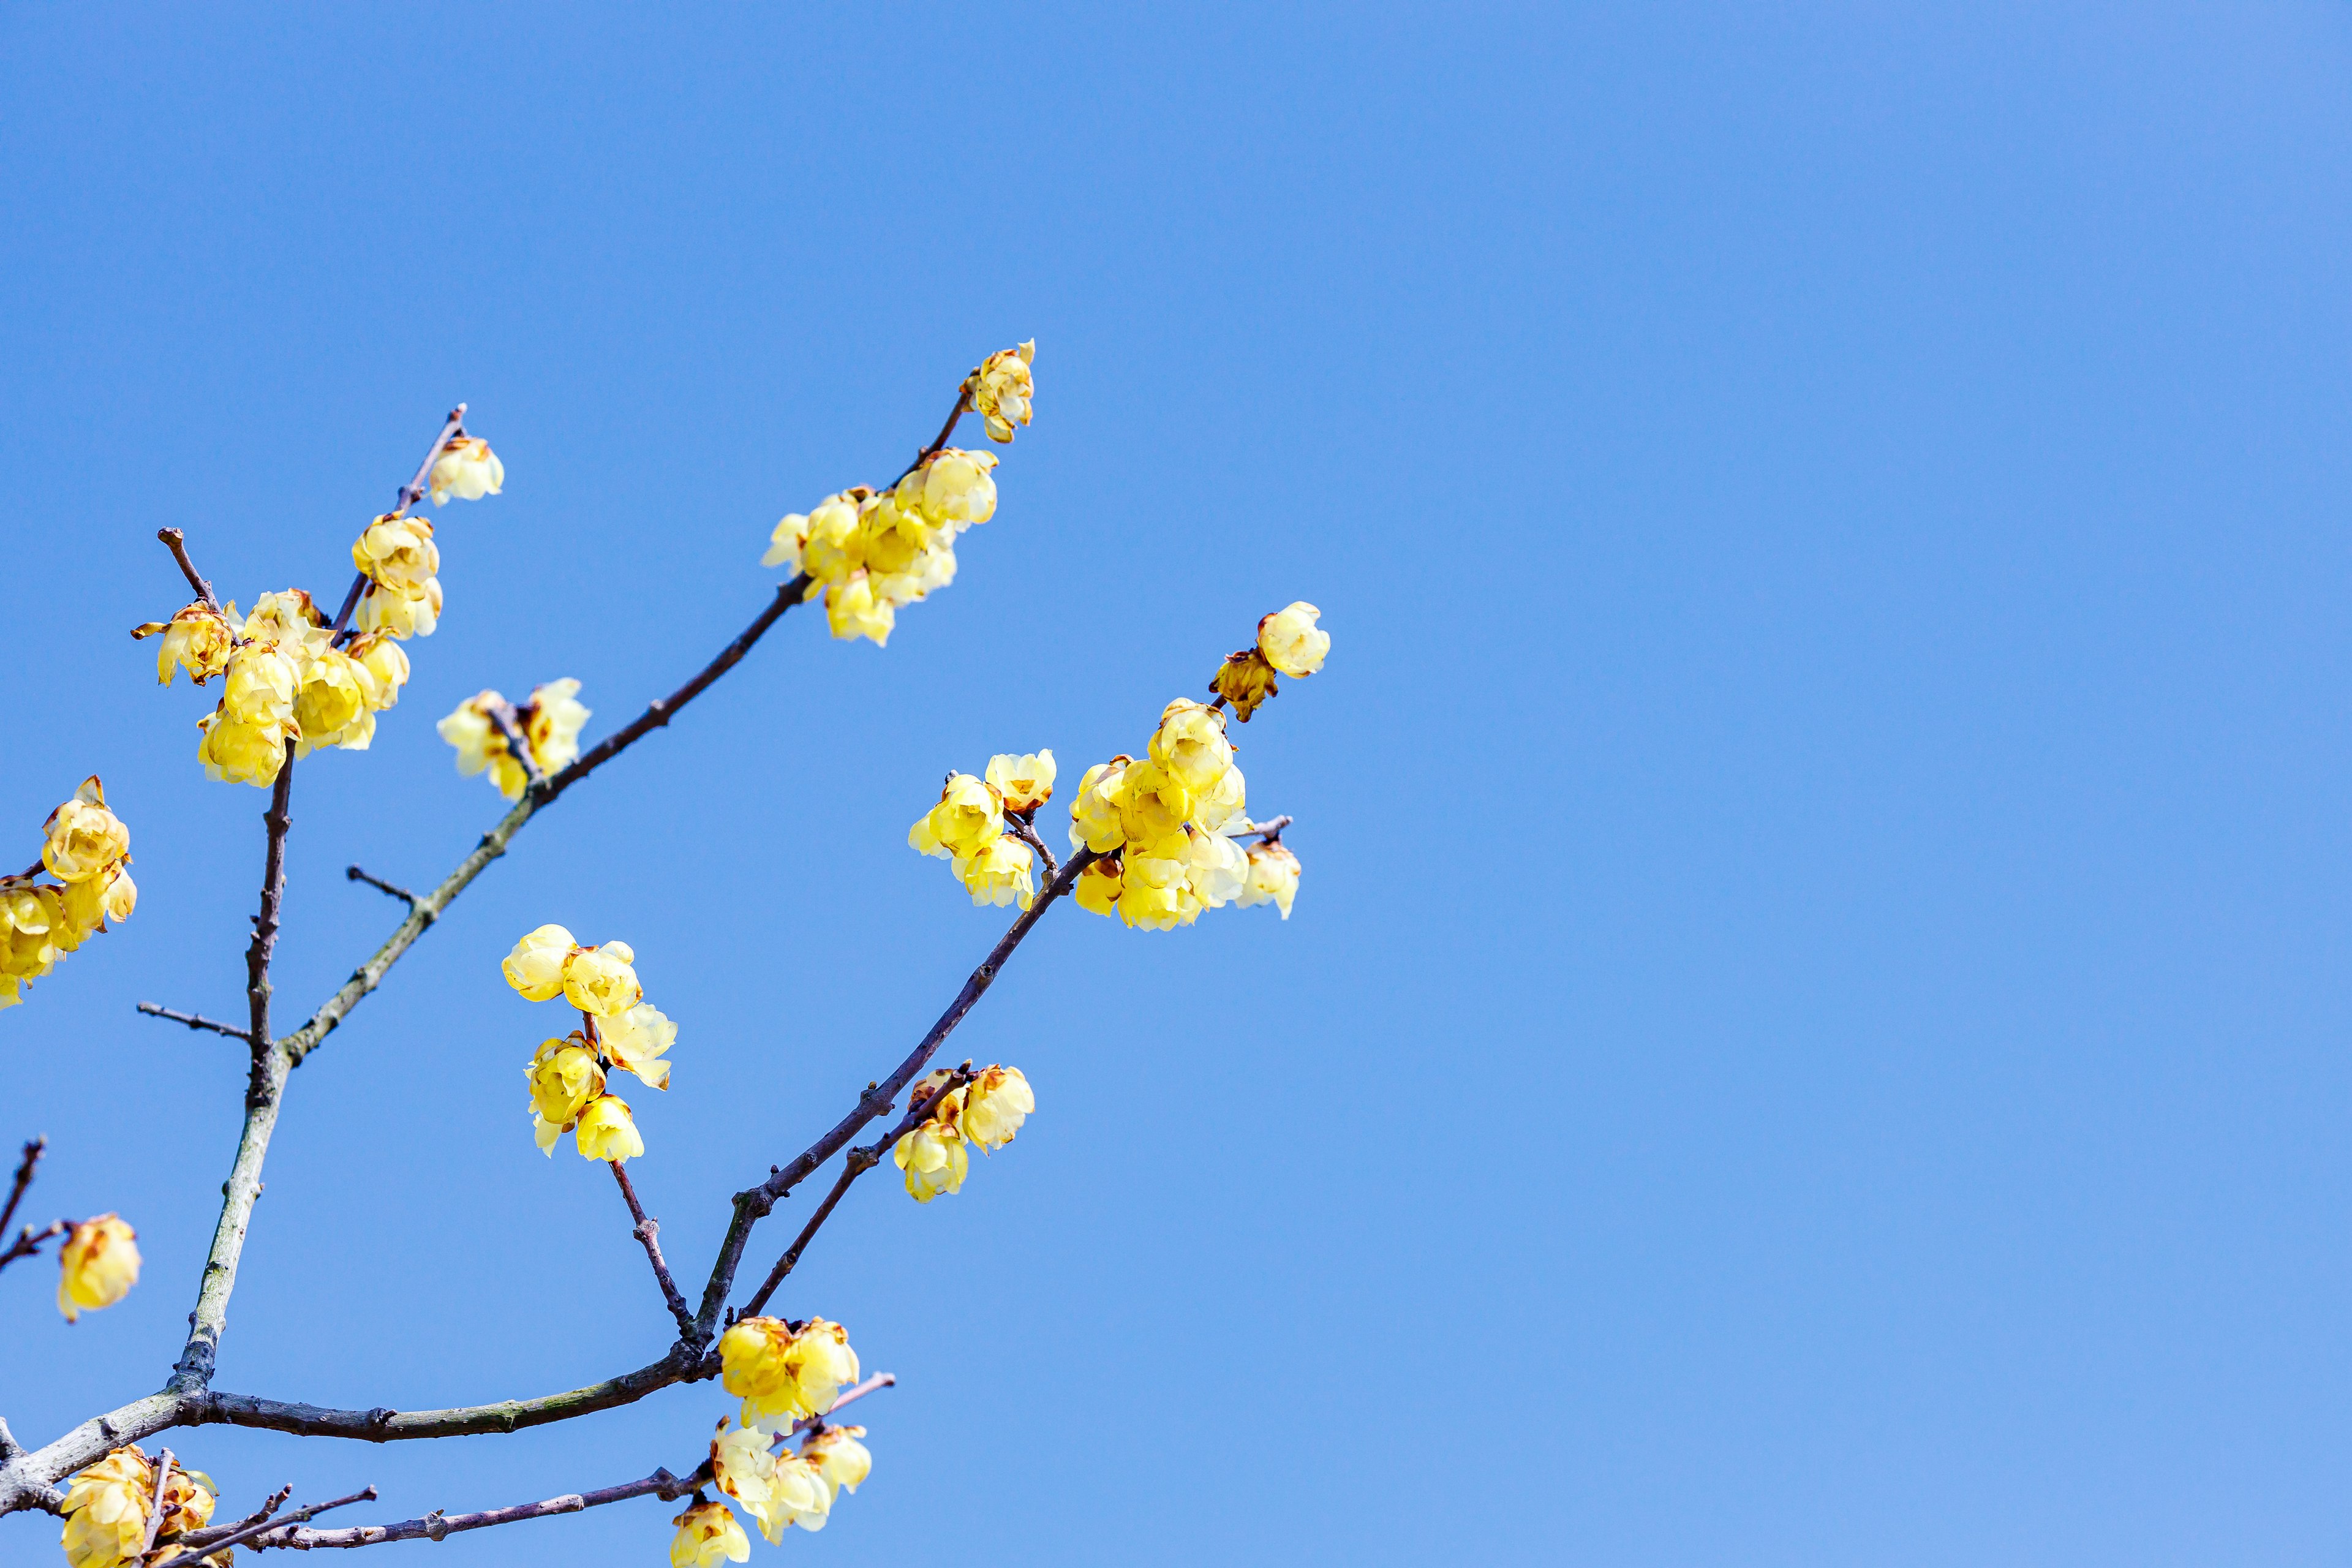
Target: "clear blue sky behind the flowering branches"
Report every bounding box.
[0,5,2352,1568]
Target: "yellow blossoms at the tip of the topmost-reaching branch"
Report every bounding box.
[760,343,1037,646]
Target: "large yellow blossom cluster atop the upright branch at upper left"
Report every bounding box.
[132,437,506,788]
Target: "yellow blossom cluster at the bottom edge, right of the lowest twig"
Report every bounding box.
[691,1316,873,1568]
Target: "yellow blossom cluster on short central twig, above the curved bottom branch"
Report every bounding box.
[501,926,677,1164]
